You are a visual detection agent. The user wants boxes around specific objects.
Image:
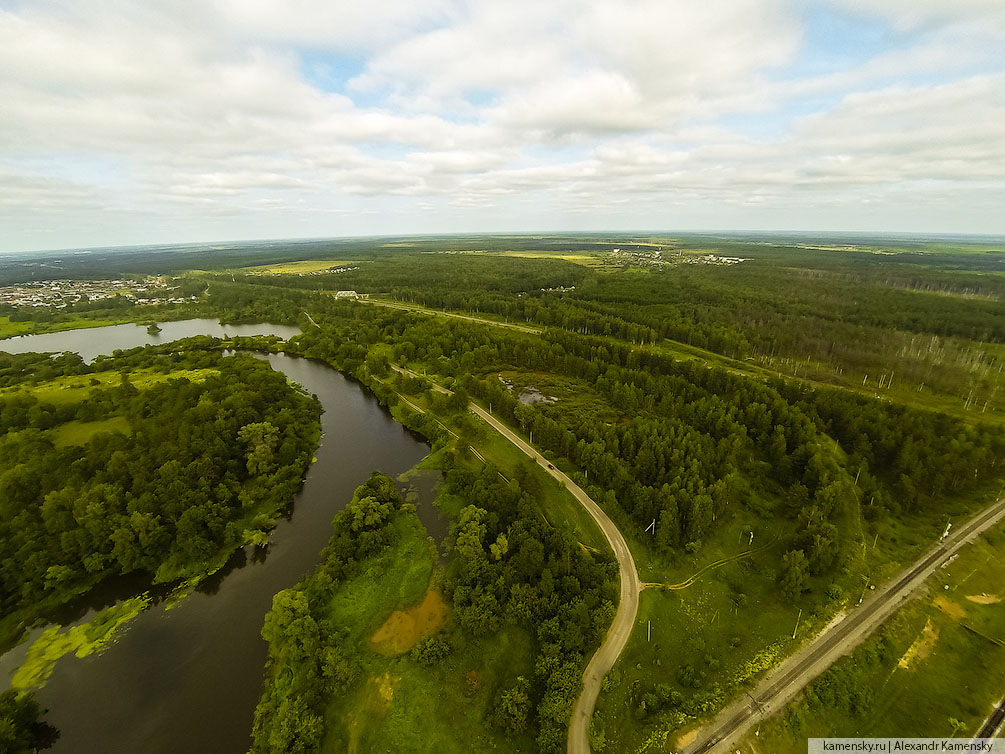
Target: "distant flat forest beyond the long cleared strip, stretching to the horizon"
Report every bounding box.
[220,243,1005,411]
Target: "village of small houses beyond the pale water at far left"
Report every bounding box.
[0,277,195,309]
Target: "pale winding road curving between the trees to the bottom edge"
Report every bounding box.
[394,367,642,754]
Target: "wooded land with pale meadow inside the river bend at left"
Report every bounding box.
[0,344,319,632]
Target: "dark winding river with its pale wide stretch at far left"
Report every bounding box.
[0,320,445,754]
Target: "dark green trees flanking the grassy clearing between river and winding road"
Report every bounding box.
[252,466,616,752]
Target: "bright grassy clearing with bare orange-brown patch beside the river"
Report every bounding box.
[322,515,533,754]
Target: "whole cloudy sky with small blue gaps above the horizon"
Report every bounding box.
[0,0,1005,250]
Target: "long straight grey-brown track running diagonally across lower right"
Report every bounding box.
[682,500,1005,754]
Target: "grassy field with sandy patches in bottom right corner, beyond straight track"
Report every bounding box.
[740,526,1005,754]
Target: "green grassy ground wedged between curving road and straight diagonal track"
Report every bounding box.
[595,516,808,752]
